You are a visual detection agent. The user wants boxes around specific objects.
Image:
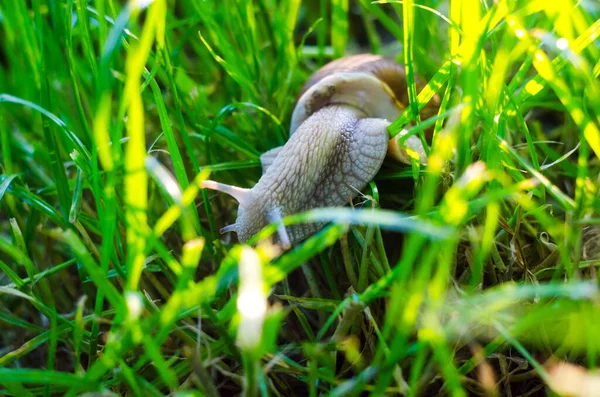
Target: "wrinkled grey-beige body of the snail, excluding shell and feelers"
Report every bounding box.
[211,105,389,243]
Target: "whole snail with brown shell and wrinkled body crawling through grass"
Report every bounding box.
[202,54,438,246]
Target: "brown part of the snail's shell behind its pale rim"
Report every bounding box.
[298,54,440,140]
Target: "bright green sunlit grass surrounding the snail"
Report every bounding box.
[0,0,600,396]
